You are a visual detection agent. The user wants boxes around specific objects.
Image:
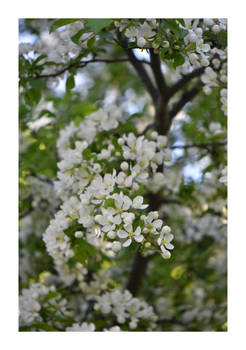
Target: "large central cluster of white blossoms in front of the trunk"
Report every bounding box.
[43,105,173,284]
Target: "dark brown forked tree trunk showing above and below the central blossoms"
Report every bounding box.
[113,31,208,296]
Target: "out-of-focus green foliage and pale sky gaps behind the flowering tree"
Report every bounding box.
[19,20,227,331]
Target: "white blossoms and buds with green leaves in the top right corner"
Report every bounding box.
[114,18,227,115]
